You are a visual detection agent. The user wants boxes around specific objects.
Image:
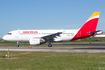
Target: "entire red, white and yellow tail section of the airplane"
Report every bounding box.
[71,12,100,41]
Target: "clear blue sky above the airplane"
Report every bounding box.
[0,0,105,38]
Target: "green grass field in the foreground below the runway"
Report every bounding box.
[0,51,105,70]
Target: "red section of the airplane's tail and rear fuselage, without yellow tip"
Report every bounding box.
[70,18,99,41]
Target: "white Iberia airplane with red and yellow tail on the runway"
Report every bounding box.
[3,12,102,47]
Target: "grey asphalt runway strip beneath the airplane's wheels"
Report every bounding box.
[0,44,105,53]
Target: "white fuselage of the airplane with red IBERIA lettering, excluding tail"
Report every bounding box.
[3,30,78,42]
